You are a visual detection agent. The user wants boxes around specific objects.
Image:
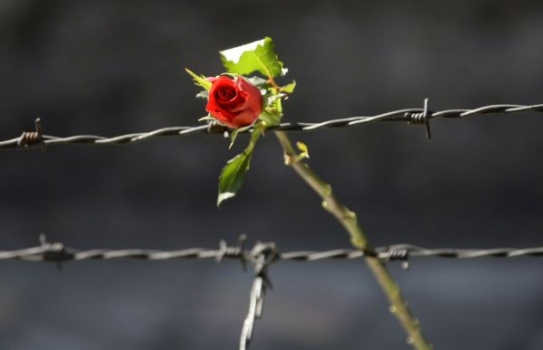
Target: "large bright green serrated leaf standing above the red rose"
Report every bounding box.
[220,37,287,78]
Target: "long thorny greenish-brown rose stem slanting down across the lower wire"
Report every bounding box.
[275,131,432,350]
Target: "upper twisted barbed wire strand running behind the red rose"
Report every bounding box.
[0,99,543,150]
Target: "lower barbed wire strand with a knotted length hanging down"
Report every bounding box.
[0,234,543,350]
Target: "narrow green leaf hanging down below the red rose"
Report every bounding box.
[217,148,253,207]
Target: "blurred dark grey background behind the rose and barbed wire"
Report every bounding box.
[0,0,543,350]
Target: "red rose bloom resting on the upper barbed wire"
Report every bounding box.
[206,76,262,129]
